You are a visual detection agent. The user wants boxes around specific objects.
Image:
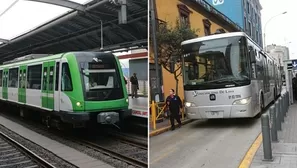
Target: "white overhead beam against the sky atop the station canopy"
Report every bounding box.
[26,0,86,11]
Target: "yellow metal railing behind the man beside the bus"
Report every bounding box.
[150,101,185,130]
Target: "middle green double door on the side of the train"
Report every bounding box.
[18,66,27,103]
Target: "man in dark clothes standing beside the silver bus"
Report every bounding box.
[166,89,183,131]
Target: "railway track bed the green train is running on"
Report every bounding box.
[0,111,148,168]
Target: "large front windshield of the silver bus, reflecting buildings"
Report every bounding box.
[182,37,250,90]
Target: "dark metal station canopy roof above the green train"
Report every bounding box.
[0,0,148,62]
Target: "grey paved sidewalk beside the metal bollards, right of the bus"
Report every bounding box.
[250,104,297,168]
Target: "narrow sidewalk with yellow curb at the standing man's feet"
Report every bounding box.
[150,117,193,137]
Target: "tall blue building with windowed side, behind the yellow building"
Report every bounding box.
[207,0,263,47]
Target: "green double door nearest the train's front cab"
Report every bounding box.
[42,61,55,110]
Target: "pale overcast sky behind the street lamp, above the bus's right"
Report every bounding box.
[260,0,297,59]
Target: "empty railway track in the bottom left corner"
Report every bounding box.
[0,132,55,168]
